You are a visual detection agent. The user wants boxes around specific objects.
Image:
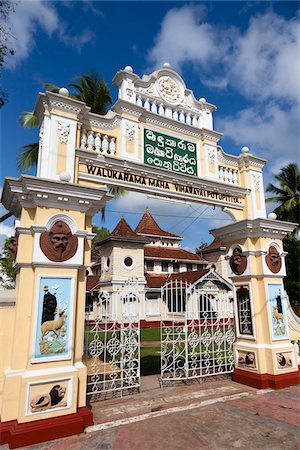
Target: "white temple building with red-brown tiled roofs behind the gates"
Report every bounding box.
[86,210,233,323]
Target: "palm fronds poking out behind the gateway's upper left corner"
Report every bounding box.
[18,73,112,171]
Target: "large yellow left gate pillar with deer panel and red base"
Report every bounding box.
[0,176,107,446]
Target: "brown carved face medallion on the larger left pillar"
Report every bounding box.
[40,220,78,262]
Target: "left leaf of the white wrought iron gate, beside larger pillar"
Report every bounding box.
[84,283,140,400]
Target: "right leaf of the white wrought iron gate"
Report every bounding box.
[161,280,235,384]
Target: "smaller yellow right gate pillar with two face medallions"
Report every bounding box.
[211,218,299,389]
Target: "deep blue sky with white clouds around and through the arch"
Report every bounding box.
[0,0,300,249]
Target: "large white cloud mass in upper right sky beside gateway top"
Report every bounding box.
[149,5,300,176]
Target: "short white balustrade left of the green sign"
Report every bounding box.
[80,127,116,155]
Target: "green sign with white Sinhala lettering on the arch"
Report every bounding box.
[144,128,198,176]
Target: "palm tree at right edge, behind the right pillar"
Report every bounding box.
[266,164,300,223]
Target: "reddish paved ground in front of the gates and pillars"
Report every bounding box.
[1,376,300,450]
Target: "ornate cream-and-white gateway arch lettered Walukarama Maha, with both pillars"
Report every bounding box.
[0,64,299,447]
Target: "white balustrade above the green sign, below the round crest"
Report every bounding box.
[136,95,212,129]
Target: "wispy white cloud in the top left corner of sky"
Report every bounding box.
[6,0,94,68]
